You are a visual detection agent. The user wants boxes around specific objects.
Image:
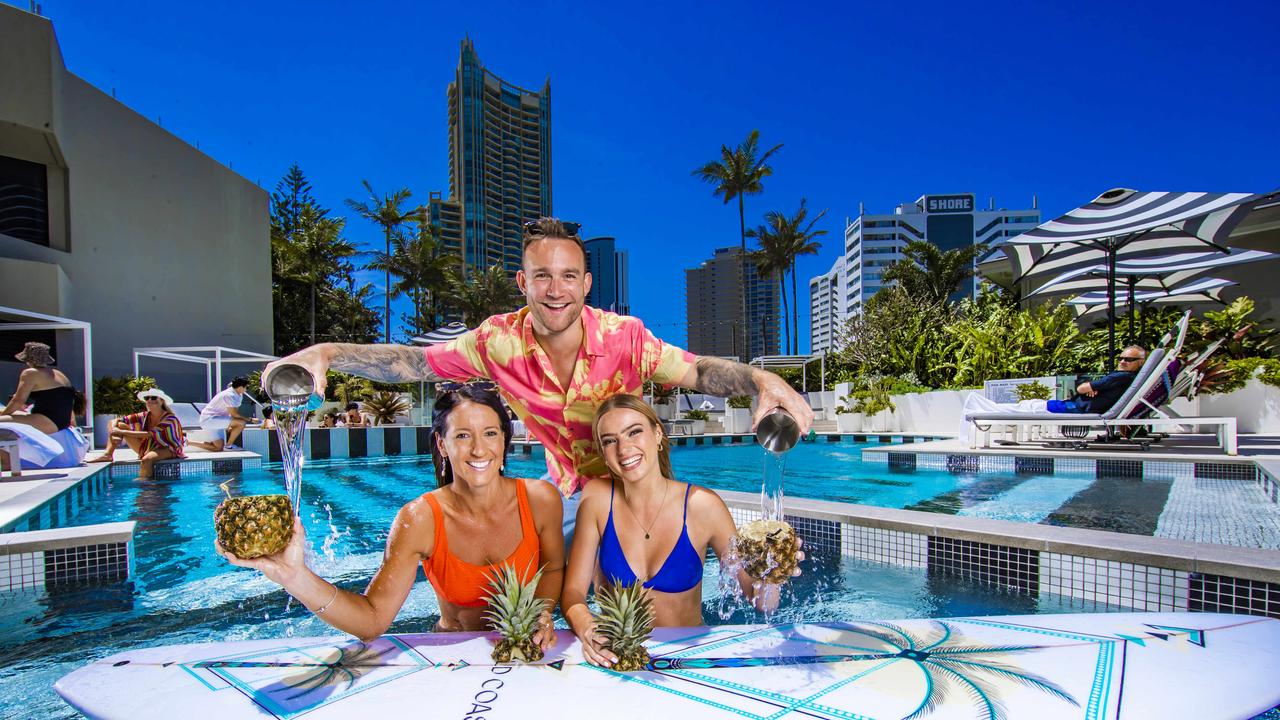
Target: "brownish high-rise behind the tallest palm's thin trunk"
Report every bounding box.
[685,247,781,363]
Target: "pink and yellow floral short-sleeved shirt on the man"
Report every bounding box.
[425,306,695,497]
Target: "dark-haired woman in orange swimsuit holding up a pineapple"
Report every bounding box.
[219,386,564,640]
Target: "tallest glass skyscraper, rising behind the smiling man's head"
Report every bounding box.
[429,40,552,273]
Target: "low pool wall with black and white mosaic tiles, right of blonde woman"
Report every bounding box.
[721,489,1280,618]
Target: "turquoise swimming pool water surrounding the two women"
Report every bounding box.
[0,446,1152,720]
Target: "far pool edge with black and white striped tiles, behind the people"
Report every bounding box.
[241,425,940,462]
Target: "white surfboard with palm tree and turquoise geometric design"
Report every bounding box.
[55,612,1280,720]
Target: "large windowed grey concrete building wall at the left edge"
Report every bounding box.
[0,4,271,392]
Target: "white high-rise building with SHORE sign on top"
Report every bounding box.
[810,195,1041,320]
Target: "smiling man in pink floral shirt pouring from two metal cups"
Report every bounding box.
[264,218,813,529]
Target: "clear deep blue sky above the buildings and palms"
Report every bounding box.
[20,0,1280,346]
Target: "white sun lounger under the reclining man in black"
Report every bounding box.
[965,313,1236,455]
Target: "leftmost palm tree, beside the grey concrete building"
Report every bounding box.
[273,205,357,345]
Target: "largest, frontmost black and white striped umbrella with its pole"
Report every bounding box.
[1005,188,1265,357]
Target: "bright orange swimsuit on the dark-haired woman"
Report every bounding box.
[422,479,540,607]
